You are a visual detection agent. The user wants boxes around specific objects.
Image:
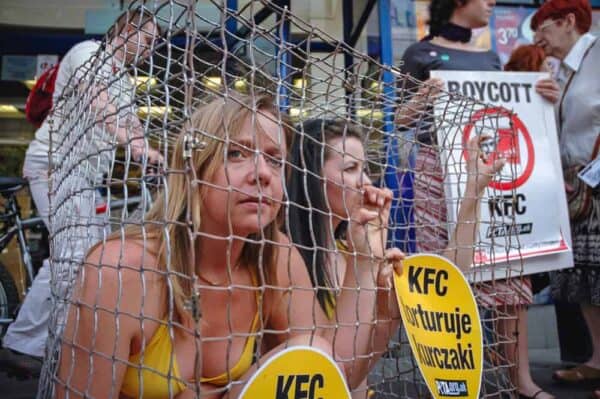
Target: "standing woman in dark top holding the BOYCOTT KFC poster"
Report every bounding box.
[401,0,560,399]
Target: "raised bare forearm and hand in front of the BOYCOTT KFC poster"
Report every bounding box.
[442,136,506,271]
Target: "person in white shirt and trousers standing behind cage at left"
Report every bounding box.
[0,8,162,378]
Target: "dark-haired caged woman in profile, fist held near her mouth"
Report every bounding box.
[287,119,504,397]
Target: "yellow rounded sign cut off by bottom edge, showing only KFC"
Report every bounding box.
[240,346,351,399]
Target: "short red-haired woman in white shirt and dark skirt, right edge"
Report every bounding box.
[531,0,600,398]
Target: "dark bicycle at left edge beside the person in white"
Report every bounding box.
[0,177,142,337]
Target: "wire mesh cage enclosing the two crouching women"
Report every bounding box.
[40,0,522,398]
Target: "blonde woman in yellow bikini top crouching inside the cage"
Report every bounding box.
[55,97,331,399]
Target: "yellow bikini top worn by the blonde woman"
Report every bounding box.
[121,273,260,399]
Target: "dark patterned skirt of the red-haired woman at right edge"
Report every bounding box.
[550,202,600,306]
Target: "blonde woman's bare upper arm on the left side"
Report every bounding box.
[55,241,149,398]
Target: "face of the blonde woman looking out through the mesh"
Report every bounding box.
[201,113,286,237]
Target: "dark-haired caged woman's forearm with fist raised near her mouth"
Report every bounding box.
[327,186,404,388]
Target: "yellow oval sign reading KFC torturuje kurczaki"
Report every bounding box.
[394,254,483,399]
